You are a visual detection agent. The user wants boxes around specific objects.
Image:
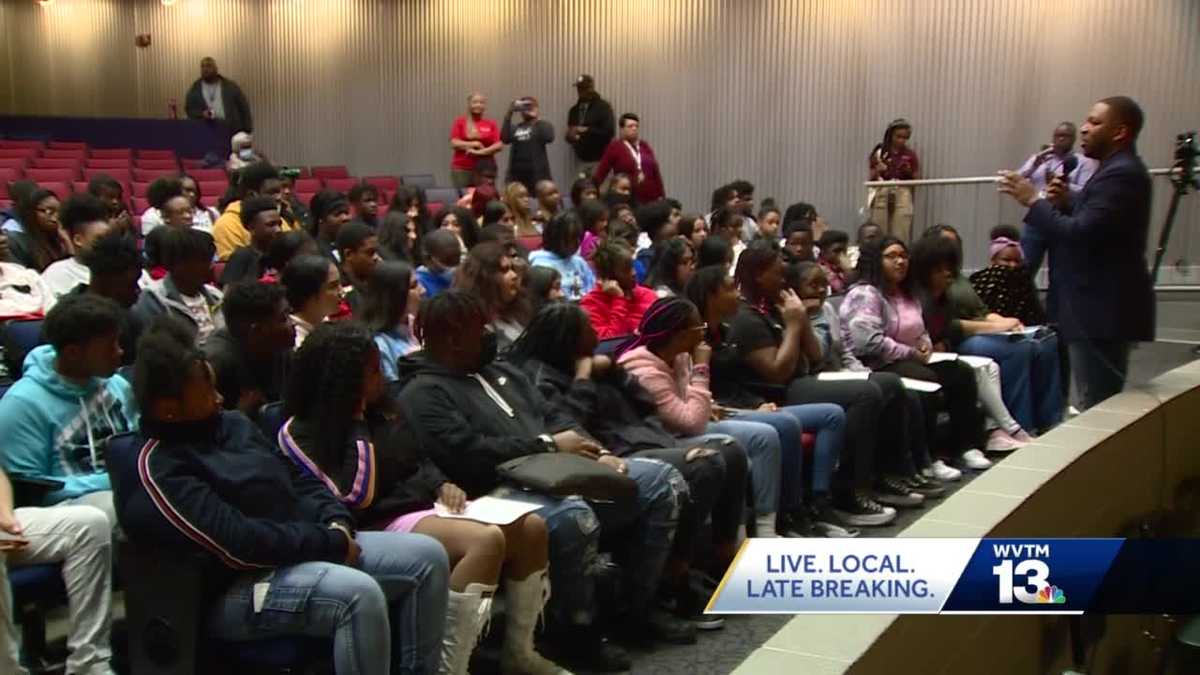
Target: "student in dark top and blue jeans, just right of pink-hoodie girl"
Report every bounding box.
[685,265,857,537]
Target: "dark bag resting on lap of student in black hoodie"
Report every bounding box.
[496,453,637,502]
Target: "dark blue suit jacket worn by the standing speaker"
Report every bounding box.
[1022,144,1154,342]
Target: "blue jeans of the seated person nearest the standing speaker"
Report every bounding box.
[956,333,1063,431]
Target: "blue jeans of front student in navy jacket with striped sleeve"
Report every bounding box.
[208,532,450,675]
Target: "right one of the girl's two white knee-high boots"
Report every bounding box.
[500,569,570,675]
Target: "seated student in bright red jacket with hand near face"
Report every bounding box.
[580,239,658,340]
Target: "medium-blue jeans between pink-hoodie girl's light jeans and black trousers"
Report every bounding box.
[738,404,846,509]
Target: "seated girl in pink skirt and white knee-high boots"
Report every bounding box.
[278,321,563,675]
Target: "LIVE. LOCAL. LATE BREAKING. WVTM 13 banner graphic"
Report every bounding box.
[708,538,1200,614]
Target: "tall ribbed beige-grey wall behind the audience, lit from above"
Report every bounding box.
[0,0,1200,269]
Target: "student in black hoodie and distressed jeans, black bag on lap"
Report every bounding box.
[400,289,695,671]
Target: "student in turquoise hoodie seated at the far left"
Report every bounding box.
[0,295,138,526]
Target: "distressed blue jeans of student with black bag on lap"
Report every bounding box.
[492,458,688,627]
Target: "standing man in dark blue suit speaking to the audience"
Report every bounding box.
[1000,96,1154,407]
